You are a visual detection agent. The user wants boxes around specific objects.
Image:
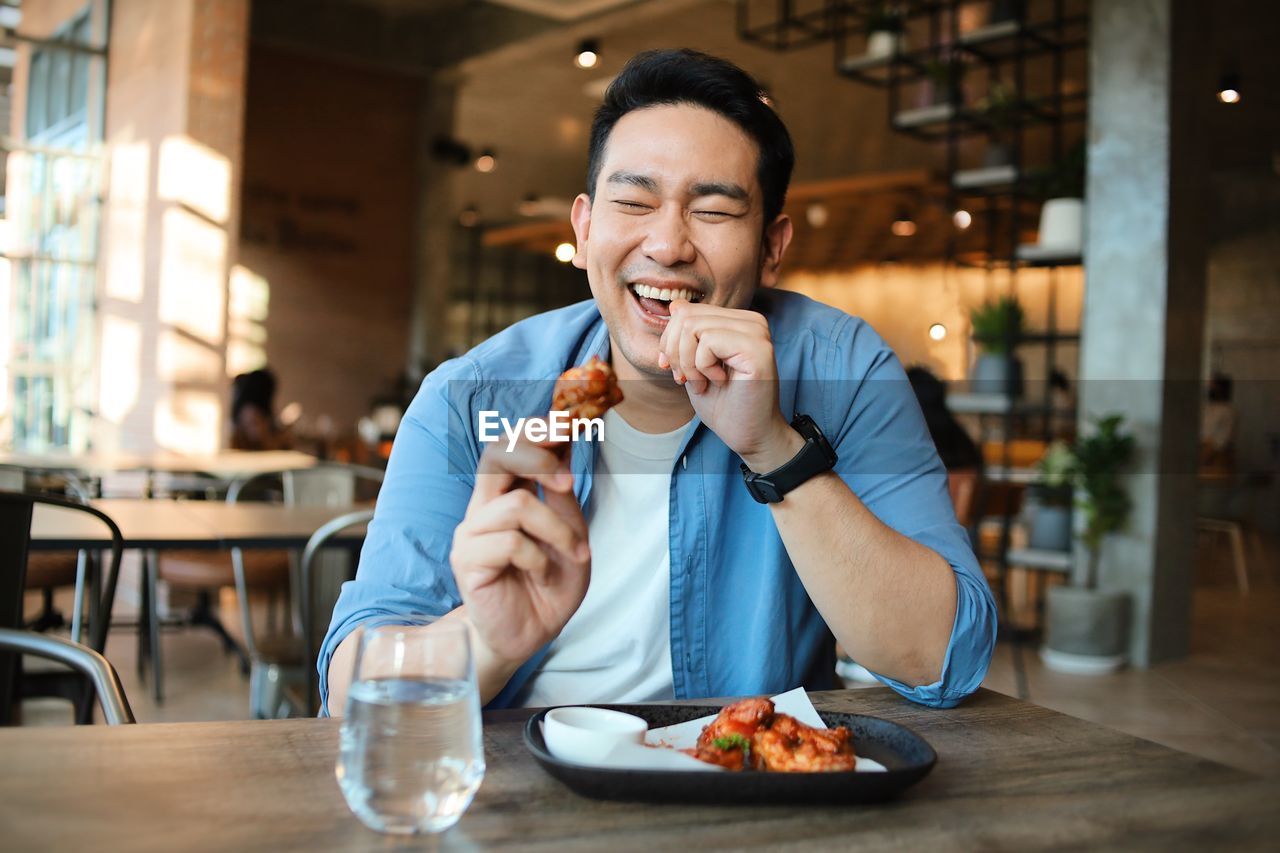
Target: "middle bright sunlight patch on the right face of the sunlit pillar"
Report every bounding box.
[160,207,227,347]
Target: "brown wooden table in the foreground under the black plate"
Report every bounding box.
[0,688,1280,850]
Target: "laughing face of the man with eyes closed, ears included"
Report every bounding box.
[573,105,791,380]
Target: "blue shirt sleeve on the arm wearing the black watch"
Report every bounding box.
[824,318,997,708]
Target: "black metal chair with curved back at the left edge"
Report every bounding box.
[0,492,124,725]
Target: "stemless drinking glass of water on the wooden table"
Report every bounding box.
[335,619,485,834]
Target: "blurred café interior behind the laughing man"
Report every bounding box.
[0,0,1280,849]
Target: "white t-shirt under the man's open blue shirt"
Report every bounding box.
[521,411,687,706]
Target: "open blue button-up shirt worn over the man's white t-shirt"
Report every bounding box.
[317,289,996,707]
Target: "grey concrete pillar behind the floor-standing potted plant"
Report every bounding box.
[1079,0,1211,666]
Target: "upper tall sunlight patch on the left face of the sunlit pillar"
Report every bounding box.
[104,142,151,302]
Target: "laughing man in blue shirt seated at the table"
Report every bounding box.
[319,51,996,712]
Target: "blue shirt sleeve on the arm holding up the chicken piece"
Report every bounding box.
[316,359,476,716]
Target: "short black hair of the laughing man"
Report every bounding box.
[586,49,796,225]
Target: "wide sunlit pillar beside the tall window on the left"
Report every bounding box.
[95,0,248,453]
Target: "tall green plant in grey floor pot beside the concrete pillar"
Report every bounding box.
[1041,415,1135,674]
